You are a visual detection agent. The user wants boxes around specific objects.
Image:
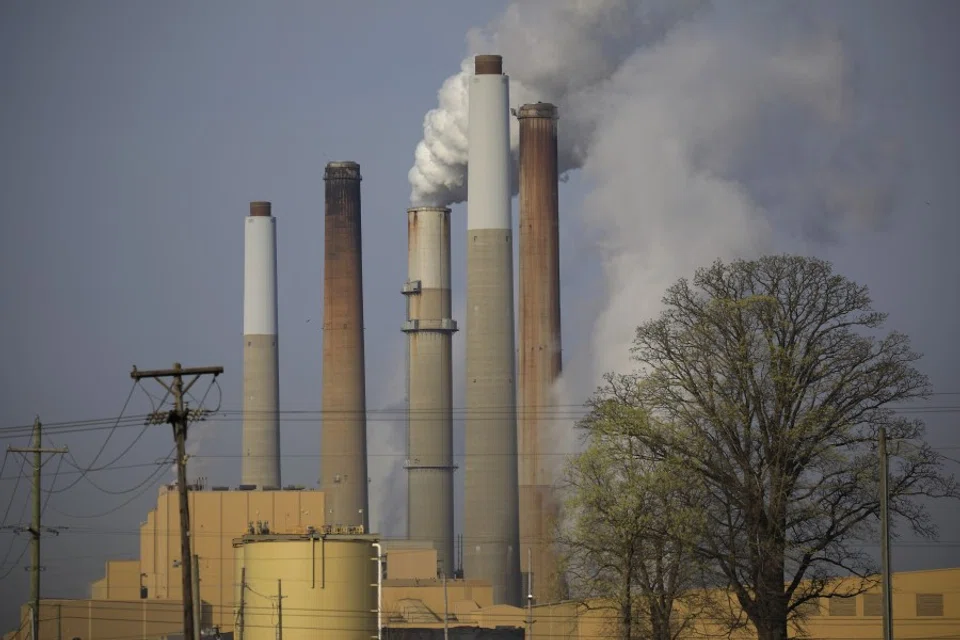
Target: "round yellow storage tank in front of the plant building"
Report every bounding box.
[233,533,377,640]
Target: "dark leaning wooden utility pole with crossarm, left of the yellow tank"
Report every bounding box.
[130,362,223,640]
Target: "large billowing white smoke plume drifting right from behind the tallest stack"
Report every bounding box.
[409,0,902,480]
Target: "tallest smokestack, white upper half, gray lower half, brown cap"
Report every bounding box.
[463,55,521,606]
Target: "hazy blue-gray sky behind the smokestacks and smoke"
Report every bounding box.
[0,0,960,628]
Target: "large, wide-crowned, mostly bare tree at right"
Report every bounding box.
[633,256,958,640]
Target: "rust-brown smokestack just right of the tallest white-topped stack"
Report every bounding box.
[517,102,566,602]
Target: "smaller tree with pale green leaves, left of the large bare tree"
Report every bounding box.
[559,375,702,640]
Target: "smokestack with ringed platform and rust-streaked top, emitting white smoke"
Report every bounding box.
[403,207,457,576]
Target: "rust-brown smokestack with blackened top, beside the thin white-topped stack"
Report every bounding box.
[320,162,369,531]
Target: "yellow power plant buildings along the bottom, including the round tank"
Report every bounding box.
[4,486,960,640]
